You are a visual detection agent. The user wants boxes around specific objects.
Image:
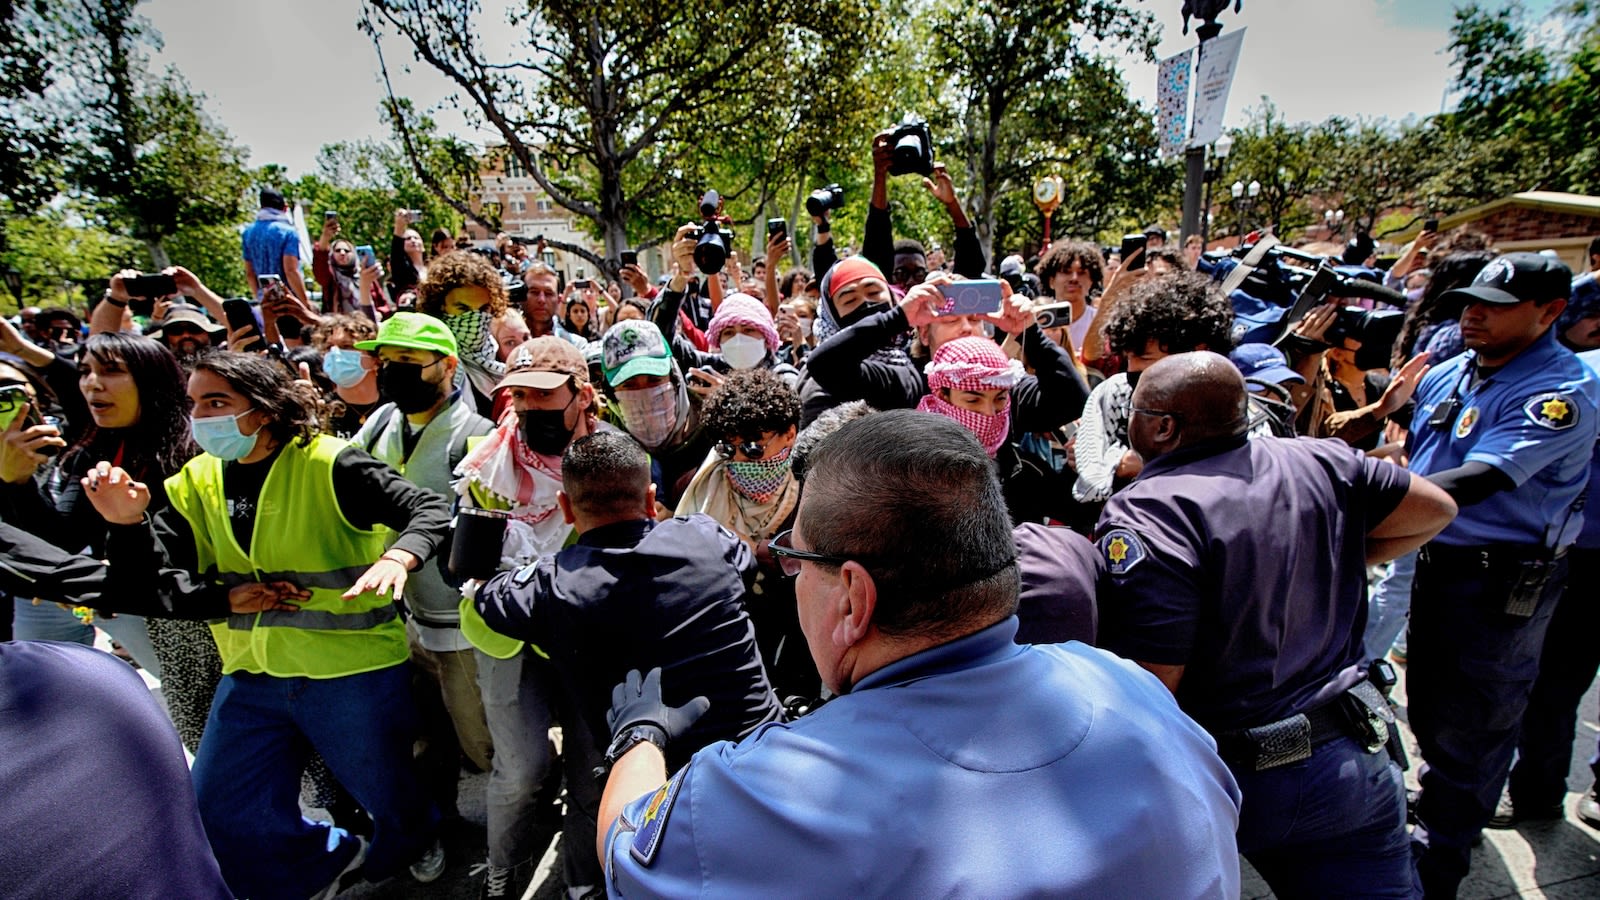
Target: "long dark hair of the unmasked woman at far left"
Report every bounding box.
[66,331,198,480]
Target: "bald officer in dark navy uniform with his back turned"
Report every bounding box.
[1096,352,1454,897]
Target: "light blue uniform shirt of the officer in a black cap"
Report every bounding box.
[1410,328,1600,549]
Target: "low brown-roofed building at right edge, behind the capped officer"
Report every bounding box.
[1390,191,1600,272]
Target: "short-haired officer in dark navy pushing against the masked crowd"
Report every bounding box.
[475,431,782,889]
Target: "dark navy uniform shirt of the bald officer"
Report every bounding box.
[1096,437,1410,733]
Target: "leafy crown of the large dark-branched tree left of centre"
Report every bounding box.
[363,0,874,267]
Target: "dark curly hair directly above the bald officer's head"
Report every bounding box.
[1106,271,1234,354]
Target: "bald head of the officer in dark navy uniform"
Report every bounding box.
[1128,344,1250,460]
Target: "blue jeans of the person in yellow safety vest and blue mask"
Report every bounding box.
[194,665,438,900]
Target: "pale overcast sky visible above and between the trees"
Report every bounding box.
[141,0,1555,176]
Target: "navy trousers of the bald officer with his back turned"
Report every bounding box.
[1232,738,1419,898]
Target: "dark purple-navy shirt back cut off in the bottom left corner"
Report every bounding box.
[0,641,234,898]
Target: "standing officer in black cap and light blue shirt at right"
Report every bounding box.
[1406,253,1600,897]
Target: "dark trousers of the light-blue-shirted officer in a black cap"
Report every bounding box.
[1406,544,1571,897]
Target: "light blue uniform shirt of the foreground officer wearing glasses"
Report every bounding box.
[605,617,1240,900]
